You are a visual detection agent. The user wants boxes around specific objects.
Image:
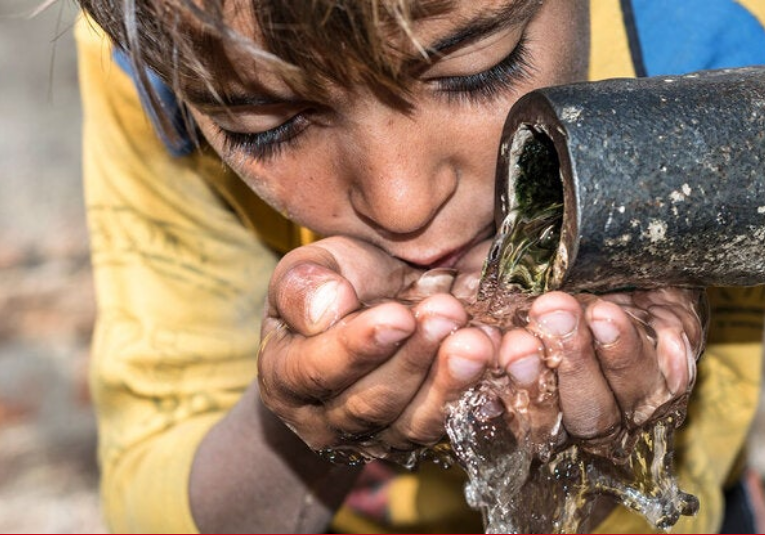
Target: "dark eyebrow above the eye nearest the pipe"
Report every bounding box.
[426,0,542,56]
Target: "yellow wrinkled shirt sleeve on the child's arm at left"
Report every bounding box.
[76,15,276,533]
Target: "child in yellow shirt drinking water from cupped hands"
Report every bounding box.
[73,0,762,532]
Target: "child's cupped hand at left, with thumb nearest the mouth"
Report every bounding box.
[258,237,497,456]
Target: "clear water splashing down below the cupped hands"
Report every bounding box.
[447,376,698,533]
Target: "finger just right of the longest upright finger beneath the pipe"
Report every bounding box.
[586,300,671,425]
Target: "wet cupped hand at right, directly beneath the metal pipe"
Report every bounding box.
[499,289,704,452]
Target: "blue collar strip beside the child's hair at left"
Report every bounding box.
[113,48,196,157]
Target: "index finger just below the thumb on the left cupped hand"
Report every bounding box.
[258,302,416,405]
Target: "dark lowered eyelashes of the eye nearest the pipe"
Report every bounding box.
[432,36,531,104]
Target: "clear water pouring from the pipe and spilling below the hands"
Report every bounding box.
[446,204,698,533]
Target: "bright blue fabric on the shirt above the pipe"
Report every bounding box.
[632,0,765,76]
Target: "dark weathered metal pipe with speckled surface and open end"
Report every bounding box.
[496,67,765,291]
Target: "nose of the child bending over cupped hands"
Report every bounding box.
[346,108,459,235]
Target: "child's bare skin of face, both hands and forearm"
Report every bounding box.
[173,0,702,532]
